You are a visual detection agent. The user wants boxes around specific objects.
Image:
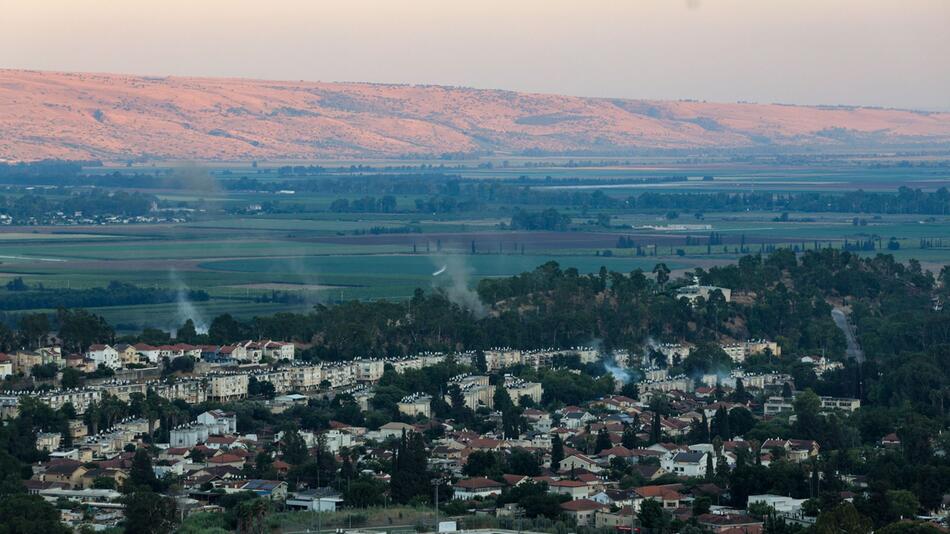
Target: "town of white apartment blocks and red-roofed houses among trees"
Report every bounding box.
[0,340,884,532]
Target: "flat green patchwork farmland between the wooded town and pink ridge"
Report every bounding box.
[0,158,950,330]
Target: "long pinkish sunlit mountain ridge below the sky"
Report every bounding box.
[0,70,950,161]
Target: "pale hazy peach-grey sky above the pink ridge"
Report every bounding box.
[0,0,950,110]
